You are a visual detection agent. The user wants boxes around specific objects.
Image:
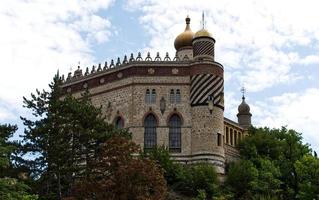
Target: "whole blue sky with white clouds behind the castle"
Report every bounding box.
[0,0,319,151]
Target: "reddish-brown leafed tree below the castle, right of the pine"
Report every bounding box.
[69,135,166,200]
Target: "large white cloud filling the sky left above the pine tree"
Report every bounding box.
[0,0,113,121]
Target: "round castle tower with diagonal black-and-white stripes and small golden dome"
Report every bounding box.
[190,13,225,174]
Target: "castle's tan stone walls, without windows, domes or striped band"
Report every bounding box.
[64,60,243,173]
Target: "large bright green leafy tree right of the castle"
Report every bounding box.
[227,127,311,200]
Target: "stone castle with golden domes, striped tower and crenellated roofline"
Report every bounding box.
[62,14,252,174]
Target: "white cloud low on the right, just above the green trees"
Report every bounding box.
[251,88,319,151]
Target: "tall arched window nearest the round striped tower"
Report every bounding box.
[169,114,182,152]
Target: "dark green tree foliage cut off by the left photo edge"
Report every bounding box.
[0,124,37,200]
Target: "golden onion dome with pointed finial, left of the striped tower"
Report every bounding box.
[174,16,194,51]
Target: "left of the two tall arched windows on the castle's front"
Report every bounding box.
[144,114,157,149]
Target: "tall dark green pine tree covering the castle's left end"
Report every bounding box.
[21,74,128,199]
